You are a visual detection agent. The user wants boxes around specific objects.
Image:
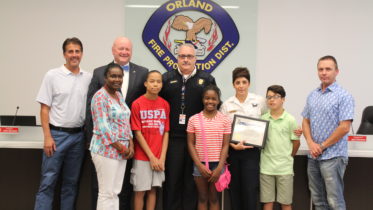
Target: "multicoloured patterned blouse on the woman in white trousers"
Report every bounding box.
[89,87,132,160]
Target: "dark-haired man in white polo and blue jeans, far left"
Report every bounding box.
[35,37,92,210]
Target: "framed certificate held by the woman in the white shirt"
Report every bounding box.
[231,115,269,148]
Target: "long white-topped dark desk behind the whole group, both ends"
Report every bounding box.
[0,127,373,210]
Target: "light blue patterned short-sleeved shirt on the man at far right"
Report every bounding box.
[302,82,355,160]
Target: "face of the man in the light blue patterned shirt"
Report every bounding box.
[317,59,339,87]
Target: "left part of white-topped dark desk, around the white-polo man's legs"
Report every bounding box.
[0,126,91,210]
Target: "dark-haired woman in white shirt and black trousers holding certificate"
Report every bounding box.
[220,67,267,210]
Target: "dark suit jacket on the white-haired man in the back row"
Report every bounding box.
[85,62,149,142]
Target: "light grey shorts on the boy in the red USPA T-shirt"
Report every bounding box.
[131,160,165,191]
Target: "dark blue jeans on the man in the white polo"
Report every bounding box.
[35,130,85,210]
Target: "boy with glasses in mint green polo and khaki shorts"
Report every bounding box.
[260,85,301,210]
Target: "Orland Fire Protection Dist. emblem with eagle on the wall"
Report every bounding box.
[142,0,239,72]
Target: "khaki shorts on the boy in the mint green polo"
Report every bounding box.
[260,173,294,205]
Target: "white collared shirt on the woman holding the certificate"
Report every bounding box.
[220,93,267,120]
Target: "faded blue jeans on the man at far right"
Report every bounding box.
[307,157,348,210]
